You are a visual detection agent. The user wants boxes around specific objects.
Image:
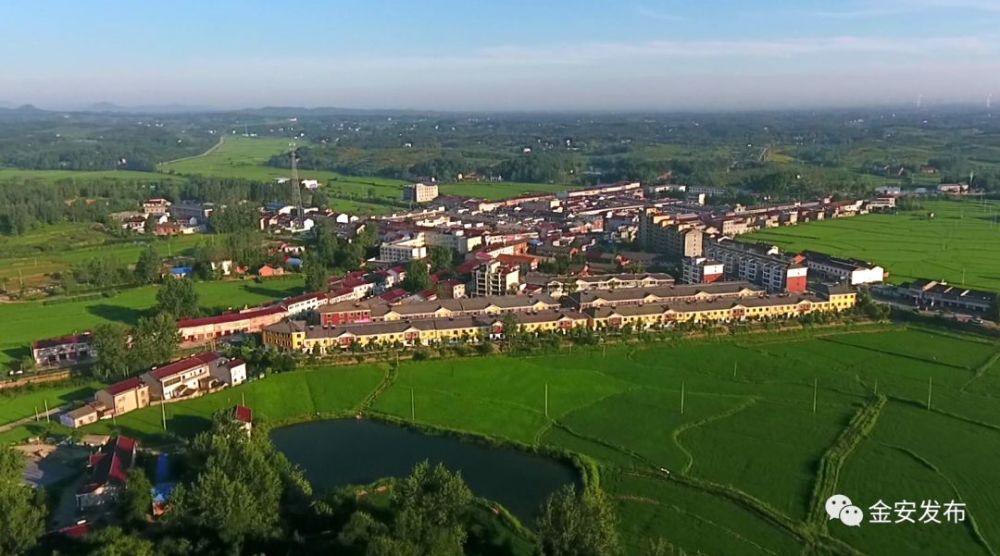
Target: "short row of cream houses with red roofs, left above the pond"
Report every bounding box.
[59,352,247,428]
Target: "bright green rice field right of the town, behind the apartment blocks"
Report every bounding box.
[748,201,1000,291]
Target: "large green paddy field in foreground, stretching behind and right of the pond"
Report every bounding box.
[5,326,1000,555]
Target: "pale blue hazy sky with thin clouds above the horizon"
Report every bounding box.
[0,0,1000,111]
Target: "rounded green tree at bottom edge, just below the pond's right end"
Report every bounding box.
[536,485,621,556]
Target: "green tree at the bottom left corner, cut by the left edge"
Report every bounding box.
[0,446,45,554]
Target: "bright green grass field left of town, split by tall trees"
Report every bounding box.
[0,276,302,365]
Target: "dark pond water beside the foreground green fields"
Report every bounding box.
[271,419,579,520]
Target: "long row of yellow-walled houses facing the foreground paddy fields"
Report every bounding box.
[263,286,857,353]
